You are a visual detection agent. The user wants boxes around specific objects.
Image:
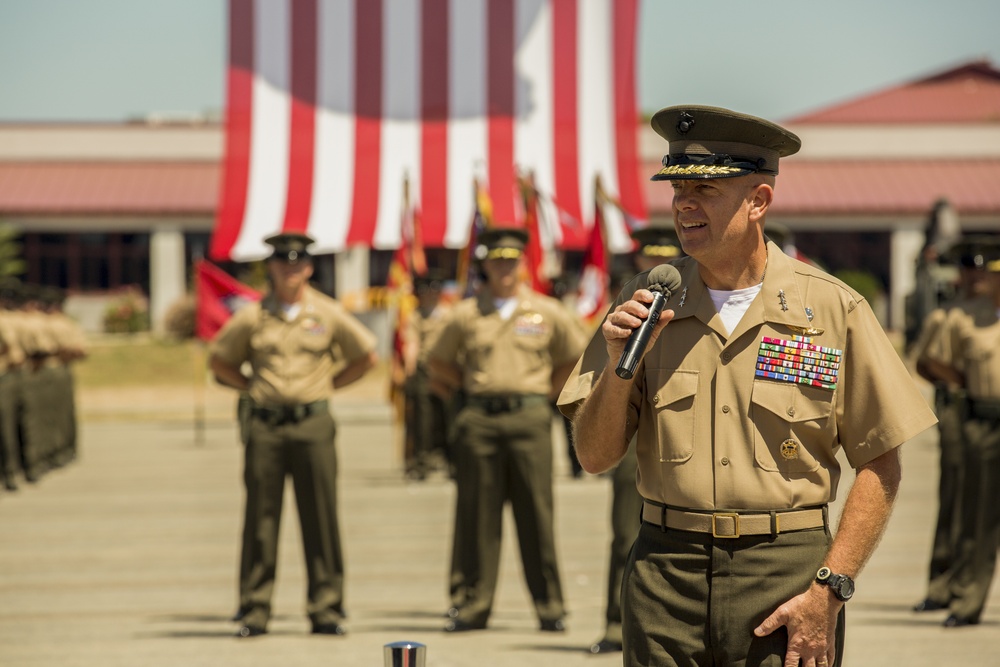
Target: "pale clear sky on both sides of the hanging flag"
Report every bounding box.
[0,0,1000,121]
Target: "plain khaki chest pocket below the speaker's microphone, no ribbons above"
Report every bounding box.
[646,368,698,463]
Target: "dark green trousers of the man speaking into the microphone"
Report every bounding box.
[622,523,844,667]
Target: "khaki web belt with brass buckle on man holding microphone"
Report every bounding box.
[642,500,826,539]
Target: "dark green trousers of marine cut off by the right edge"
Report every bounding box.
[948,417,1000,622]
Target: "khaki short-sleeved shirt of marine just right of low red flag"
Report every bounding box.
[210,287,376,405]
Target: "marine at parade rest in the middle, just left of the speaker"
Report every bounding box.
[428,227,585,632]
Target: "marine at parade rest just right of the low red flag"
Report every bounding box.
[209,233,377,637]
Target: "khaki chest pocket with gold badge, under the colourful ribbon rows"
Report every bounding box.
[750,380,834,473]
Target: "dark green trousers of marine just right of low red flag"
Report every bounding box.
[243,410,344,627]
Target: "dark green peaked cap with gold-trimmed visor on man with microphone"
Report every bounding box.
[650,105,802,181]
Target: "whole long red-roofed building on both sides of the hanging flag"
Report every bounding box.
[0,61,1000,328]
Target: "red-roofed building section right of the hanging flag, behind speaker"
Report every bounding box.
[644,61,1000,329]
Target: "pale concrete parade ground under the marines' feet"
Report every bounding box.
[0,391,1000,667]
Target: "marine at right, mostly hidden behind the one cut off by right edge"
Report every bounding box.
[910,237,997,612]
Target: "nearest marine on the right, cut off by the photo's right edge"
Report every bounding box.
[916,245,1000,628]
